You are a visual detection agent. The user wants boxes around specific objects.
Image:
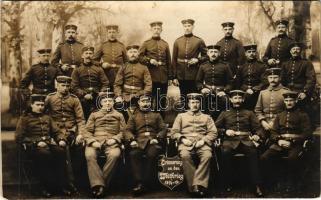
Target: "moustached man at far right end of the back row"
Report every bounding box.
[263,20,294,67]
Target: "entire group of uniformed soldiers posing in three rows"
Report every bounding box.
[16,19,316,198]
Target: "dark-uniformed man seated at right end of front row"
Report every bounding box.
[260,91,312,191]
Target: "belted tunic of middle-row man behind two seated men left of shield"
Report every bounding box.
[114,61,152,102]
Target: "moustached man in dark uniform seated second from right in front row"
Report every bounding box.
[215,90,264,197]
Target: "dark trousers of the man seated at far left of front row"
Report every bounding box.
[26,145,69,189]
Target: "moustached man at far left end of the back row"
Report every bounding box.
[51,24,84,76]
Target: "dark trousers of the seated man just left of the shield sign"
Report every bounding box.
[129,144,162,186]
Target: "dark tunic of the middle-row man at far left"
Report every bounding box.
[19,63,59,94]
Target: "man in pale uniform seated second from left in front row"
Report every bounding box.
[85,92,126,198]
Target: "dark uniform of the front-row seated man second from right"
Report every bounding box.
[215,108,264,188]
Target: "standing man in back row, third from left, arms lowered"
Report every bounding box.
[140,22,173,114]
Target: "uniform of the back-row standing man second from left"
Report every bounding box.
[93,40,127,88]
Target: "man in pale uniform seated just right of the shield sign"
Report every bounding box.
[171,93,217,197]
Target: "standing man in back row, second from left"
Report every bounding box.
[93,25,127,90]
